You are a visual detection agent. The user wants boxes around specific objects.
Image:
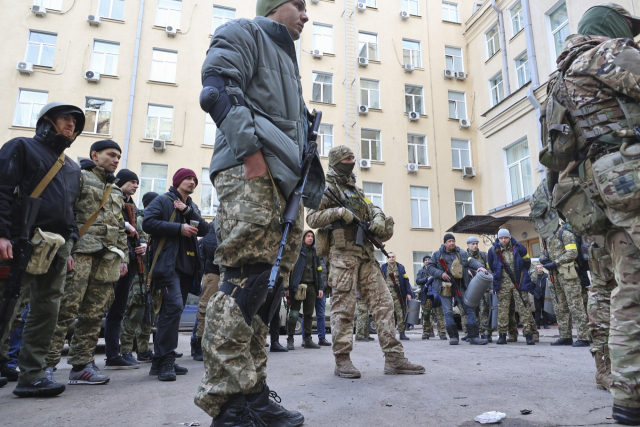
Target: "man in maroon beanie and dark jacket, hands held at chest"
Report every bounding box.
[142,168,209,381]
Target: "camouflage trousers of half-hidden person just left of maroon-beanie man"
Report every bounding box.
[120,282,151,354]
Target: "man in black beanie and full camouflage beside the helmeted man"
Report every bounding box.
[46,140,129,384]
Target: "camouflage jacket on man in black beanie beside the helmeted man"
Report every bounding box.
[73,166,129,262]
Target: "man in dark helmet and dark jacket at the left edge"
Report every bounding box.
[0,102,85,397]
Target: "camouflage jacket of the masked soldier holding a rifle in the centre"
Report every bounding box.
[307,170,384,259]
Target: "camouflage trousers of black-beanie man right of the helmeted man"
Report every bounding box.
[46,254,114,368]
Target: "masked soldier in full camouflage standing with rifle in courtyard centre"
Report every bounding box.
[307,146,424,378]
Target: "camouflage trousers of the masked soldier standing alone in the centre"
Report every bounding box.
[329,251,404,356]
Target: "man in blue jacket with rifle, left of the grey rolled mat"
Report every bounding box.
[427,234,487,345]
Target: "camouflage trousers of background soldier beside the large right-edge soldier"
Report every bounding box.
[549,274,589,341]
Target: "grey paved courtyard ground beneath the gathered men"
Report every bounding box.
[0,328,613,427]
